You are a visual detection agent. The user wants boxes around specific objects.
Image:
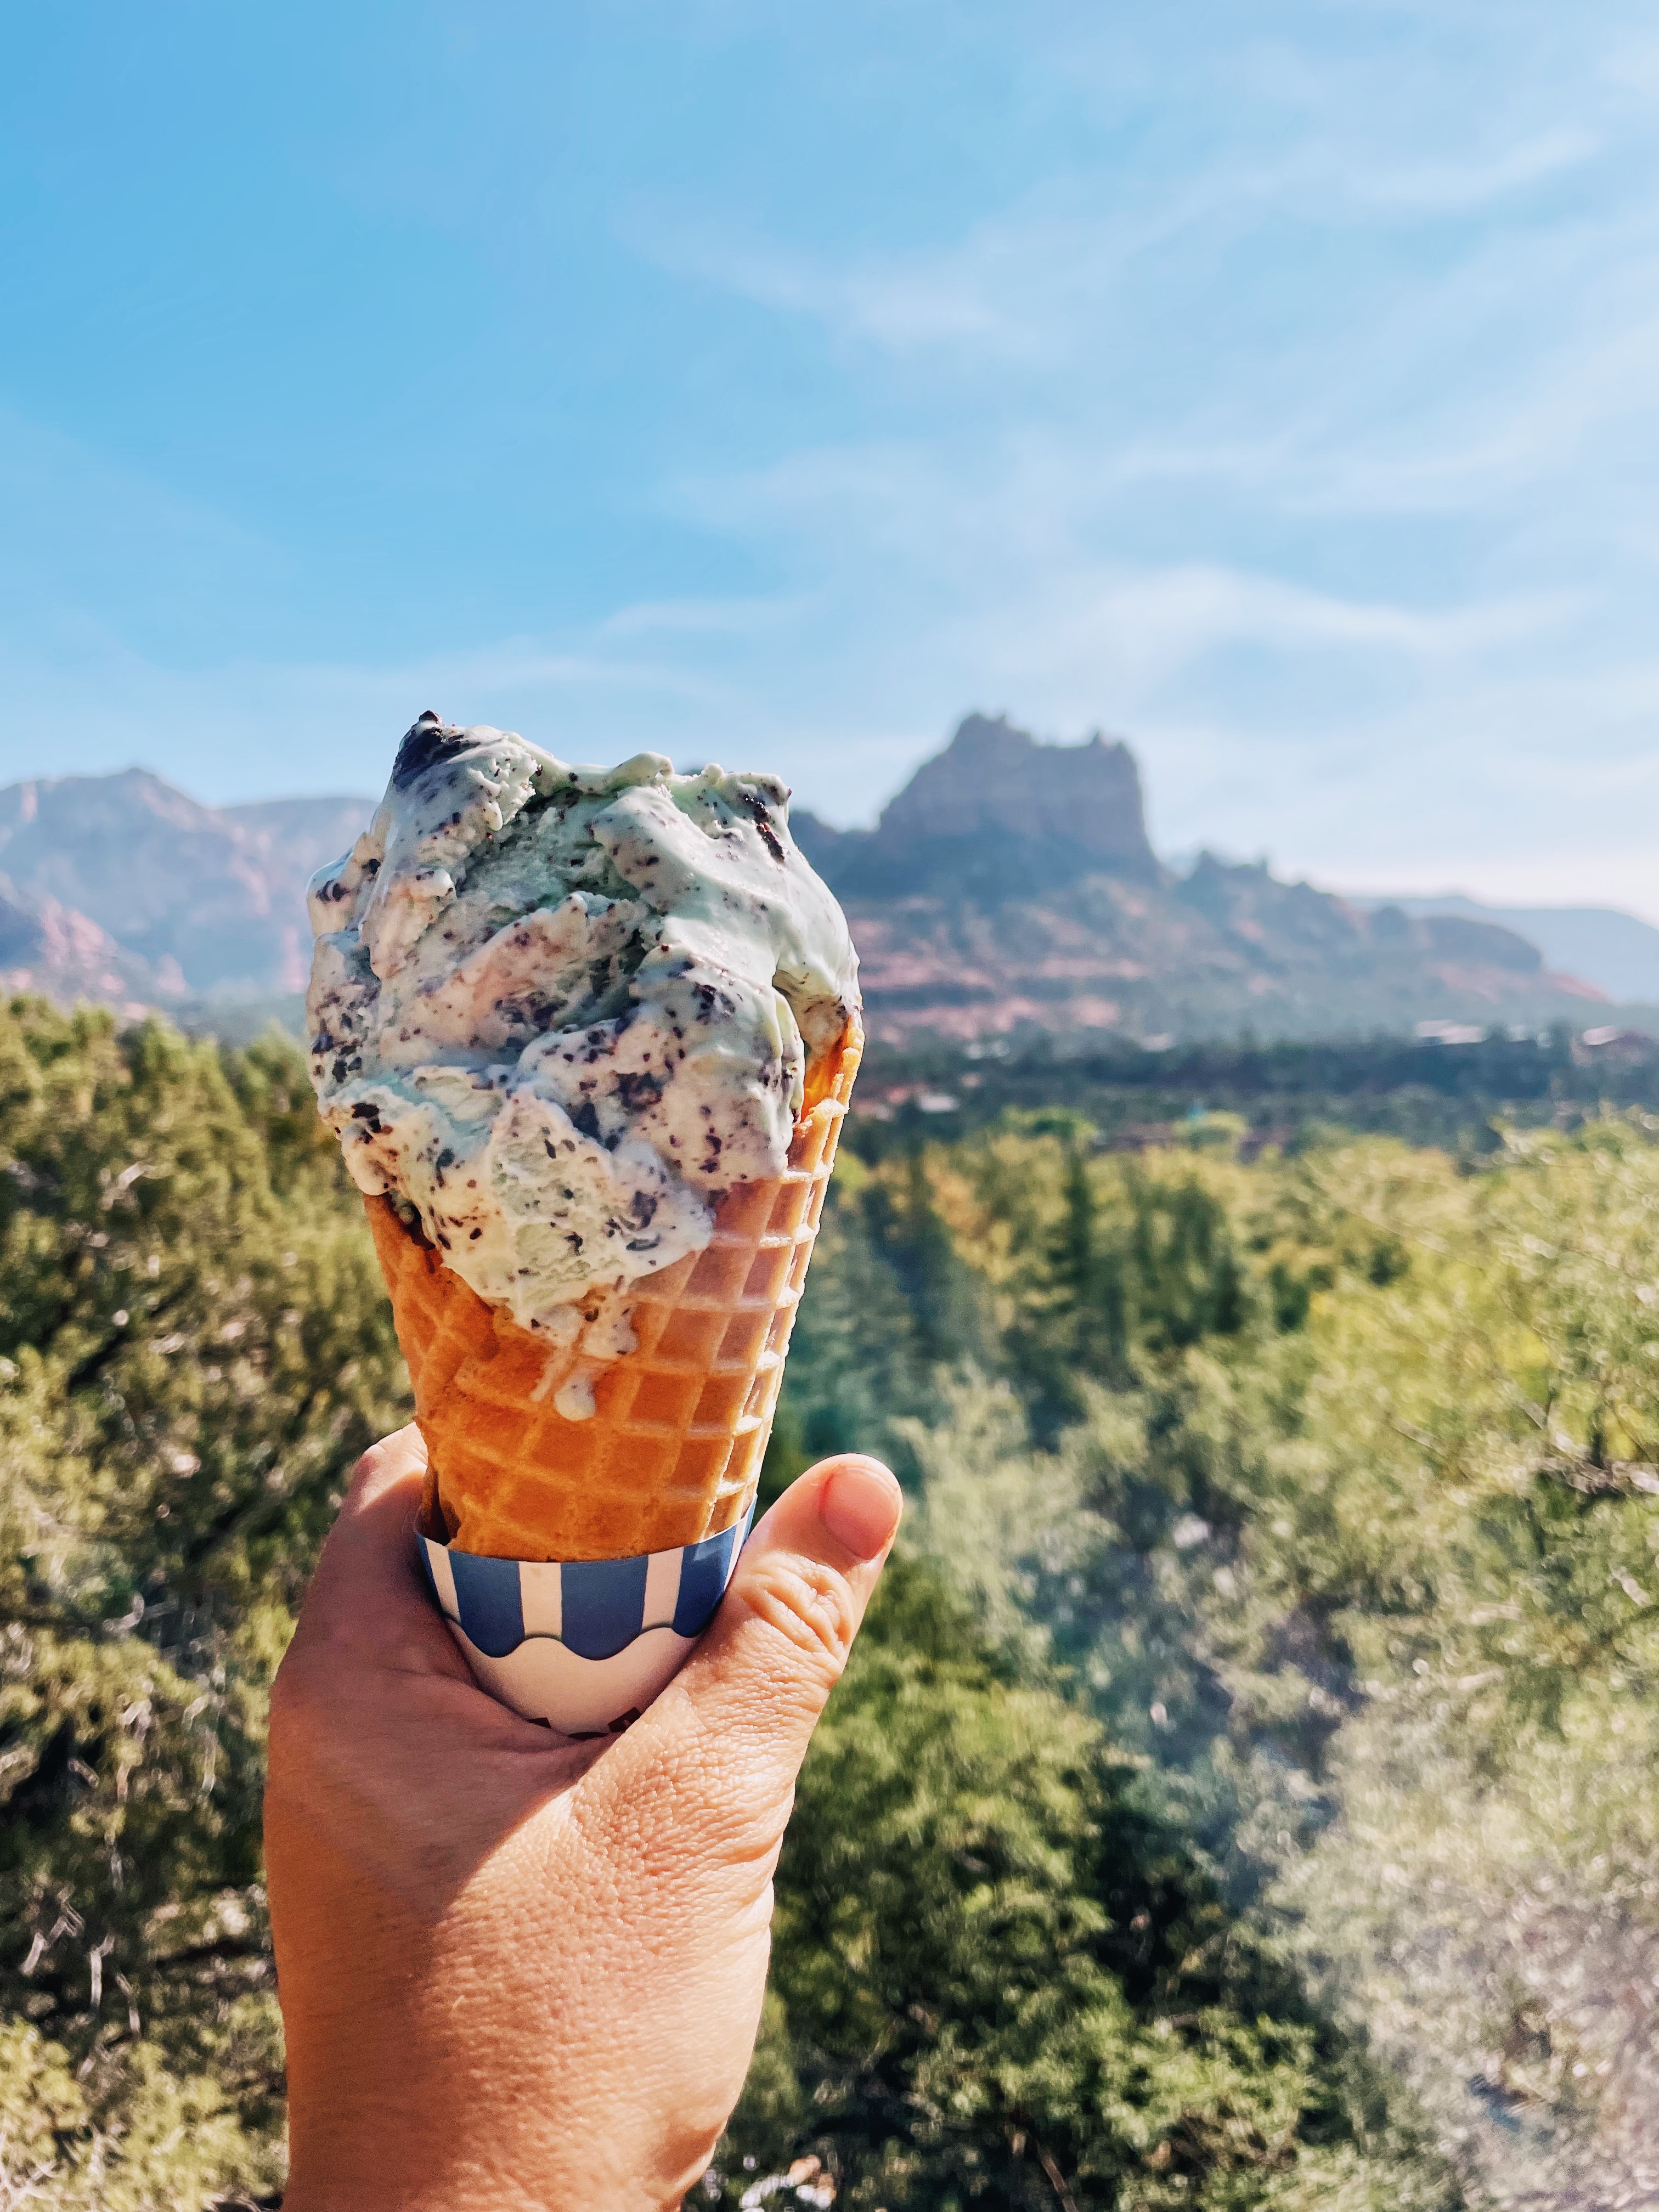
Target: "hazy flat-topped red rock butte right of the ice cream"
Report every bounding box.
[794,714,1599,1044]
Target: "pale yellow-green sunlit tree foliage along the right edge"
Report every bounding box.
[902,1117,1659,2203]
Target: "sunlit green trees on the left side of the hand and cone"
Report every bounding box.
[0,1002,405,2212]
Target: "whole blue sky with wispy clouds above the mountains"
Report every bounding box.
[0,0,1659,918]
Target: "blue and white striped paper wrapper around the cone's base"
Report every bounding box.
[416,1506,754,1736]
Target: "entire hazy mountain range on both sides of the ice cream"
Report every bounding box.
[0,712,1628,1046]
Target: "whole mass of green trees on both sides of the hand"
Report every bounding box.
[29,1002,1659,2212]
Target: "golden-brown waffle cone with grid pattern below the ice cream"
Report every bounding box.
[365,1015,862,1560]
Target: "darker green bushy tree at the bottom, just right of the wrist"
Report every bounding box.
[710,1562,1458,2212]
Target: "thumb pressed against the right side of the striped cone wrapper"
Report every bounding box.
[595,1455,905,1836]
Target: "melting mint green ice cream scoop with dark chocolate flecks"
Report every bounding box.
[307,714,858,1350]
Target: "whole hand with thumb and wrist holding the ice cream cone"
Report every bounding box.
[266,1429,900,2212]
